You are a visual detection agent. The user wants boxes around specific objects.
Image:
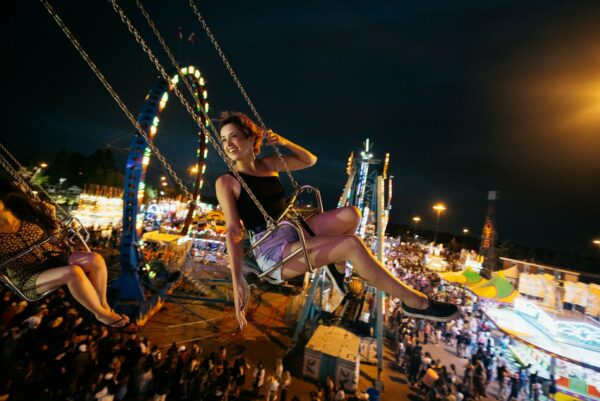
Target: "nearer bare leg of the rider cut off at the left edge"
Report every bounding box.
[36,265,128,325]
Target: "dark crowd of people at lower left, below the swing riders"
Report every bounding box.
[0,288,340,401]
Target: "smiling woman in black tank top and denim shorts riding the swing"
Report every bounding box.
[216,113,458,329]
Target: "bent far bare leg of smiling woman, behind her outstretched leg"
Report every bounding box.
[306,206,361,272]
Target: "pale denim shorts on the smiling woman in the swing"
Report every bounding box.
[250,224,300,284]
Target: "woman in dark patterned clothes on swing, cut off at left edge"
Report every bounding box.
[0,179,129,328]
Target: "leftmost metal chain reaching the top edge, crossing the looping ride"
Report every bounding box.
[40,0,192,199]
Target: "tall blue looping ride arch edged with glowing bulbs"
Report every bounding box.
[111,66,208,301]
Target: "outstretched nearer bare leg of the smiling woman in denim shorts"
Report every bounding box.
[281,235,428,308]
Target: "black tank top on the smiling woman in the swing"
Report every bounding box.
[227,171,287,230]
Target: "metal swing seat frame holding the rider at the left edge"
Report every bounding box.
[0,217,90,302]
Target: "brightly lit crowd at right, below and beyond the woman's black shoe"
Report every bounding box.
[389,244,556,401]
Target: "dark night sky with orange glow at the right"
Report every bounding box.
[0,0,600,252]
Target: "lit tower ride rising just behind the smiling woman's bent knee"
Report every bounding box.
[338,139,393,248]
